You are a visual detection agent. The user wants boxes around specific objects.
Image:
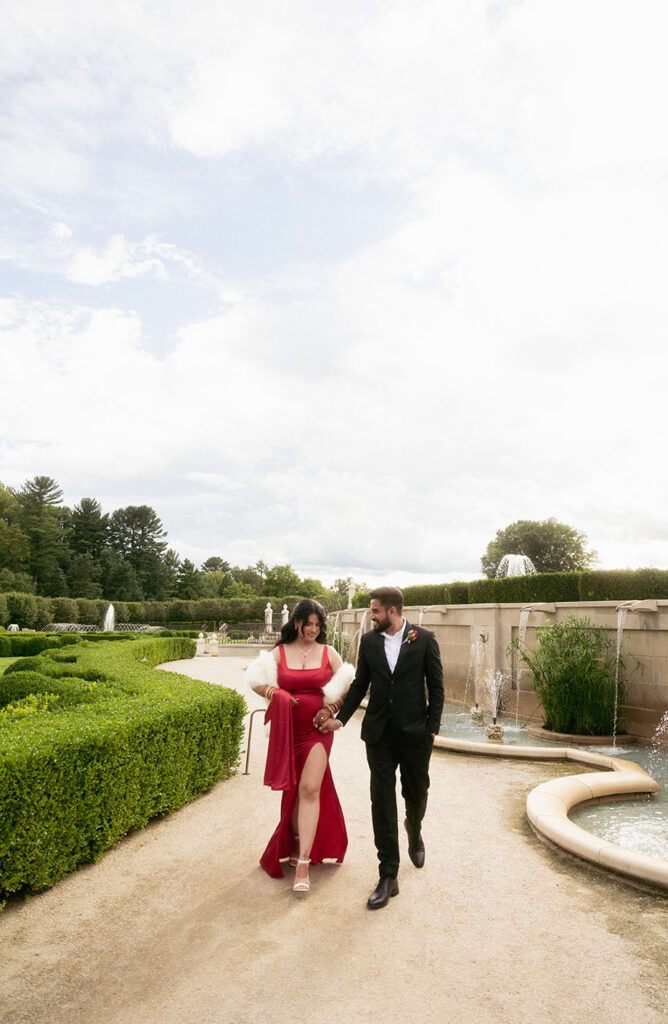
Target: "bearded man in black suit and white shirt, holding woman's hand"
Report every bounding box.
[316,587,444,910]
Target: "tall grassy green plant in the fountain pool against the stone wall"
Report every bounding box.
[508,615,625,736]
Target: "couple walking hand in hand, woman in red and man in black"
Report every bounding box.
[248,587,444,910]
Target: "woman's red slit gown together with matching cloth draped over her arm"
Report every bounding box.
[260,644,348,879]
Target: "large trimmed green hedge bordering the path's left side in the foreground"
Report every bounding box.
[0,637,246,894]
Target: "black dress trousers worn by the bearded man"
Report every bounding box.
[367,722,433,879]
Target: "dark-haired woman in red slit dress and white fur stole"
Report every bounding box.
[248,599,354,894]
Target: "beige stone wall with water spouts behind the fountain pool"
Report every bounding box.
[339,601,668,737]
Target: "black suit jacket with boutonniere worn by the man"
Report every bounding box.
[336,623,444,743]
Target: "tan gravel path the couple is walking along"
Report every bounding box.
[0,657,668,1024]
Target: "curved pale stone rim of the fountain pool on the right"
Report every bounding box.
[434,736,668,889]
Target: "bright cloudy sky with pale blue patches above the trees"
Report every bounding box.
[0,0,668,586]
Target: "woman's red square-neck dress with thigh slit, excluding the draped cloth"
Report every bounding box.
[260,644,348,879]
